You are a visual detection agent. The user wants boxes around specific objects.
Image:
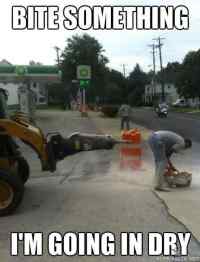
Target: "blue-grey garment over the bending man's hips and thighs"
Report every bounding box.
[149,133,167,163]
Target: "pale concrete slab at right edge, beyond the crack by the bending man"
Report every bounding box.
[156,143,200,242]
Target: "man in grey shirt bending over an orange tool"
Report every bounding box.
[149,131,192,191]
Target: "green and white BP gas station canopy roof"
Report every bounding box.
[0,65,61,82]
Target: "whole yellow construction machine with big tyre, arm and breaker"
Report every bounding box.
[0,89,129,216]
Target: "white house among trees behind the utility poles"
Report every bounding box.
[144,83,179,104]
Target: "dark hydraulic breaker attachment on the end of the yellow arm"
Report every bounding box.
[47,133,131,171]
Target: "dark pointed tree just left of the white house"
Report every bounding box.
[128,64,148,106]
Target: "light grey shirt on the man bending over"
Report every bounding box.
[155,131,185,156]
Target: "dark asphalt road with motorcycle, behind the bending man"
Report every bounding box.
[133,108,200,142]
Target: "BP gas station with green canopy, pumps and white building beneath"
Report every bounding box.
[0,60,61,119]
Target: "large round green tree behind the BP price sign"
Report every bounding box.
[62,34,108,102]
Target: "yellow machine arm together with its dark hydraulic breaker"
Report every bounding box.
[0,115,130,172]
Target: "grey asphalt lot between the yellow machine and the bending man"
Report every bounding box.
[0,111,200,262]
